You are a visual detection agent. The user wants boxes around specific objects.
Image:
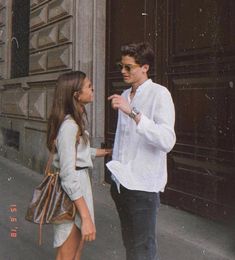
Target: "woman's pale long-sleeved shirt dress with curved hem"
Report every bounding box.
[53,115,96,247]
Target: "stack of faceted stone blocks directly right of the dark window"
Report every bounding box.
[29,0,74,74]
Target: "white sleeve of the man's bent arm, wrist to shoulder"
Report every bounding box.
[137,90,176,152]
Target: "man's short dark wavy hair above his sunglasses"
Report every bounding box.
[121,42,154,67]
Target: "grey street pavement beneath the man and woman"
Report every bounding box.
[0,157,235,260]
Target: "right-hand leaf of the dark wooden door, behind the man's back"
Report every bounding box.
[160,0,235,220]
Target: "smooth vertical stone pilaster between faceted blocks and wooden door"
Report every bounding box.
[74,0,106,182]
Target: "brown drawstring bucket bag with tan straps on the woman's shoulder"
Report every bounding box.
[25,143,76,245]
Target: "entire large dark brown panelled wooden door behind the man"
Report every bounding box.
[105,0,235,219]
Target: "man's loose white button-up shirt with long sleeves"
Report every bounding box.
[106,79,176,192]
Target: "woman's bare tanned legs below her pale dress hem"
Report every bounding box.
[56,225,82,260]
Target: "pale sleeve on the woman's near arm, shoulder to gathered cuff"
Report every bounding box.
[57,120,83,200]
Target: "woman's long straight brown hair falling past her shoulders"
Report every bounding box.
[47,71,87,152]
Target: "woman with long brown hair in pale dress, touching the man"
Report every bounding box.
[47,71,110,260]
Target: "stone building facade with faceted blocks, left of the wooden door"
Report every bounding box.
[0,0,105,181]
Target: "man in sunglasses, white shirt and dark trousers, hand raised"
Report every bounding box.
[107,43,176,260]
